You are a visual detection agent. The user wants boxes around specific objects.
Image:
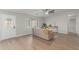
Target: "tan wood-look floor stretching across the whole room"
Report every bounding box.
[0,34,79,50]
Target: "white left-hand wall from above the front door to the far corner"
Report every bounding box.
[0,10,41,36]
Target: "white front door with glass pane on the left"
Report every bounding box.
[3,15,16,38]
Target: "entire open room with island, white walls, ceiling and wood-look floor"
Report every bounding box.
[0,9,79,50]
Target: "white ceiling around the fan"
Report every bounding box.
[0,9,79,17]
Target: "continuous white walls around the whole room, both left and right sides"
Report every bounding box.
[0,10,79,35]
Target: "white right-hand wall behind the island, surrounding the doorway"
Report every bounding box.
[45,10,79,35]
